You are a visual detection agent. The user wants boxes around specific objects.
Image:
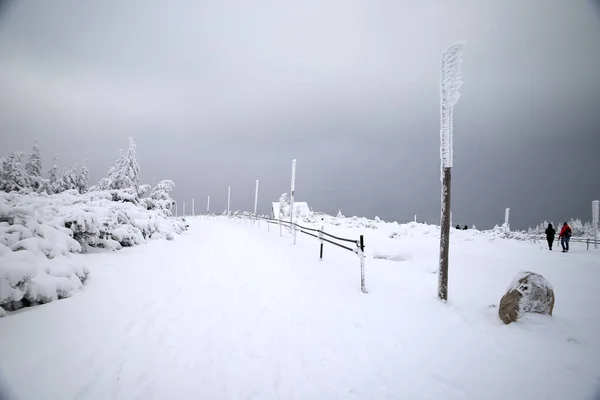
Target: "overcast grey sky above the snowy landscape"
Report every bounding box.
[0,0,600,228]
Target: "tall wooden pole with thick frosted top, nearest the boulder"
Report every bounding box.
[438,42,464,301]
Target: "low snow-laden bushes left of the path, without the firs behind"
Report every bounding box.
[0,190,186,311]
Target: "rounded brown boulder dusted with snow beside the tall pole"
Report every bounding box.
[498,272,554,324]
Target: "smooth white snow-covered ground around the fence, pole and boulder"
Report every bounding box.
[0,218,600,400]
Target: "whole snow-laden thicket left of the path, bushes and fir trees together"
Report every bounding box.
[0,139,187,315]
